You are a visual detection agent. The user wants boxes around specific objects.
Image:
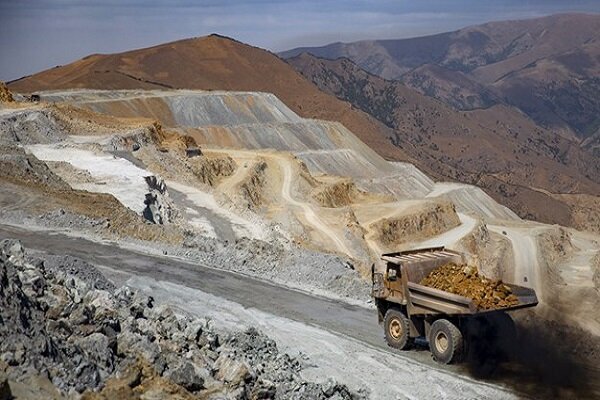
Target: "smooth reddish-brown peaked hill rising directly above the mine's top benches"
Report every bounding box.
[8,35,410,164]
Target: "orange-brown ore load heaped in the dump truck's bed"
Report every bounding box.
[421,263,519,310]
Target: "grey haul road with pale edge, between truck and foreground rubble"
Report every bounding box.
[0,225,518,399]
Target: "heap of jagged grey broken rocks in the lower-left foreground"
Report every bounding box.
[0,240,362,399]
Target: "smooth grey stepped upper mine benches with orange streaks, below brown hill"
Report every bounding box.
[41,90,518,219]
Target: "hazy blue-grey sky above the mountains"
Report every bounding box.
[0,0,600,81]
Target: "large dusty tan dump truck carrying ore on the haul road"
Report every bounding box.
[371,247,538,364]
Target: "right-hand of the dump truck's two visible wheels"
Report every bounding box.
[429,319,465,364]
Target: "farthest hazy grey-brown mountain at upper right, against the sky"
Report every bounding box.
[281,14,600,138]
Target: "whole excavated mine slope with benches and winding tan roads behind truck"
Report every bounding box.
[0,89,600,384]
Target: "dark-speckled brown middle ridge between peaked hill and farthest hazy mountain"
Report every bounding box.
[288,53,600,229]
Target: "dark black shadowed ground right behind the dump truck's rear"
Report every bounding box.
[466,314,600,399]
